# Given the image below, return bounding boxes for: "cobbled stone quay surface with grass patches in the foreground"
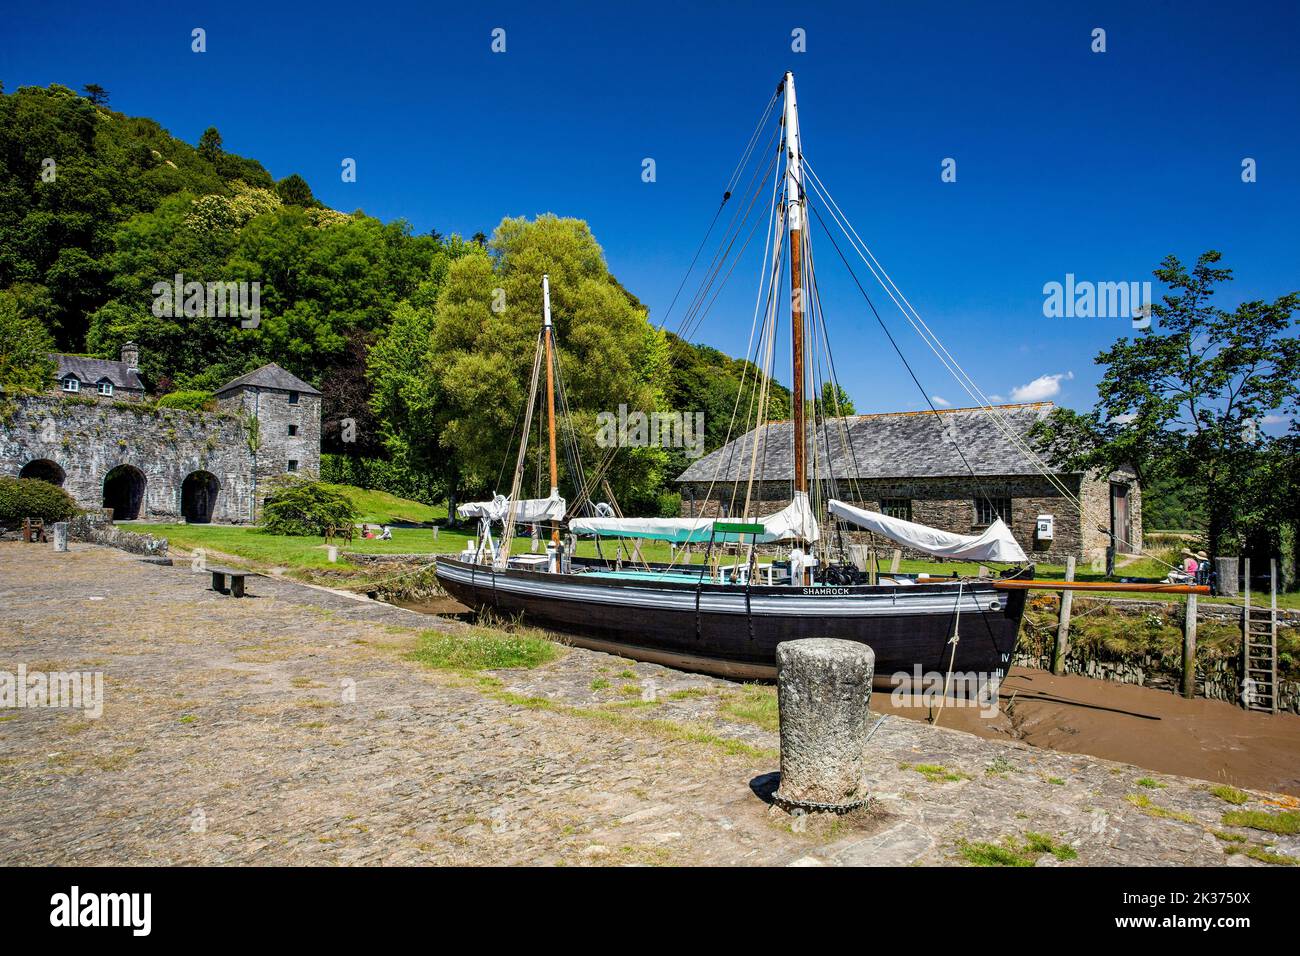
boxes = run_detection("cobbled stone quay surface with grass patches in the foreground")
[0,544,1300,865]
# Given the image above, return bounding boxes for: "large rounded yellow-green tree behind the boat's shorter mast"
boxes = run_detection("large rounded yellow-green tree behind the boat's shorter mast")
[371,215,667,507]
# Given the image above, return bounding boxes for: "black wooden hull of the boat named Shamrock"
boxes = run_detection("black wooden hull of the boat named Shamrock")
[437,558,1026,687]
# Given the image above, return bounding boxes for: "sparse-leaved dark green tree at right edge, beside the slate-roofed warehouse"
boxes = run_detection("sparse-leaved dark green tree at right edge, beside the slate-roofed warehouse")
[1039,251,1300,554]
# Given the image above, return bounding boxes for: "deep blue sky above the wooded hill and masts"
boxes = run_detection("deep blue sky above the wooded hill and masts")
[0,0,1300,421]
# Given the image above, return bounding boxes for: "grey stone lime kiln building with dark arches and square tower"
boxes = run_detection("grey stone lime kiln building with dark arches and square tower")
[0,343,321,523]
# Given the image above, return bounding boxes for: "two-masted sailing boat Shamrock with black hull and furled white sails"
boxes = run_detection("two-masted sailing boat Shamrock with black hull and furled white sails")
[437,73,1032,684]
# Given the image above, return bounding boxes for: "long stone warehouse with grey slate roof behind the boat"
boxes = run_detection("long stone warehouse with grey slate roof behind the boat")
[677,402,1141,563]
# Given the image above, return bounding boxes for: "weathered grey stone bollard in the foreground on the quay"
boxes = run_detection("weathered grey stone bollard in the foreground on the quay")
[772,637,876,813]
